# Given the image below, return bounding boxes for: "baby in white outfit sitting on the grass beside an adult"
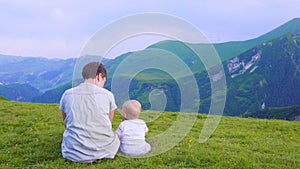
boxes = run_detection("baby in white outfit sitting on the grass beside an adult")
[116,100,151,156]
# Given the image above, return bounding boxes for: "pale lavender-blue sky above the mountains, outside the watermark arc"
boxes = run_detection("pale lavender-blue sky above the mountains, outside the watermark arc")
[0,0,300,59]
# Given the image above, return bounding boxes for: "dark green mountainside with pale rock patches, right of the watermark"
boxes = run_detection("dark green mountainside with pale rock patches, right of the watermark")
[224,34,300,115]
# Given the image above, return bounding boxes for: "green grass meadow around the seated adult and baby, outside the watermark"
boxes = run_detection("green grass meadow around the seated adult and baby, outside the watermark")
[0,99,300,169]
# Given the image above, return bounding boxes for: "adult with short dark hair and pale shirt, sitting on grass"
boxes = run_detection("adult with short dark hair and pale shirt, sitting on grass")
[60,62,120,162]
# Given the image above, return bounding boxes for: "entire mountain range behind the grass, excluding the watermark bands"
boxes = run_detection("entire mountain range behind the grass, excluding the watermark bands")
[0,18,300,118]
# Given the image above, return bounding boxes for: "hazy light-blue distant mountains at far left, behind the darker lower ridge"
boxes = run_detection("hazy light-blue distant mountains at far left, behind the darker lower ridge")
[0,55,76,91]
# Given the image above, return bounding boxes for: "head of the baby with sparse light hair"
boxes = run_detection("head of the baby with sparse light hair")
[122,100,142,120]
